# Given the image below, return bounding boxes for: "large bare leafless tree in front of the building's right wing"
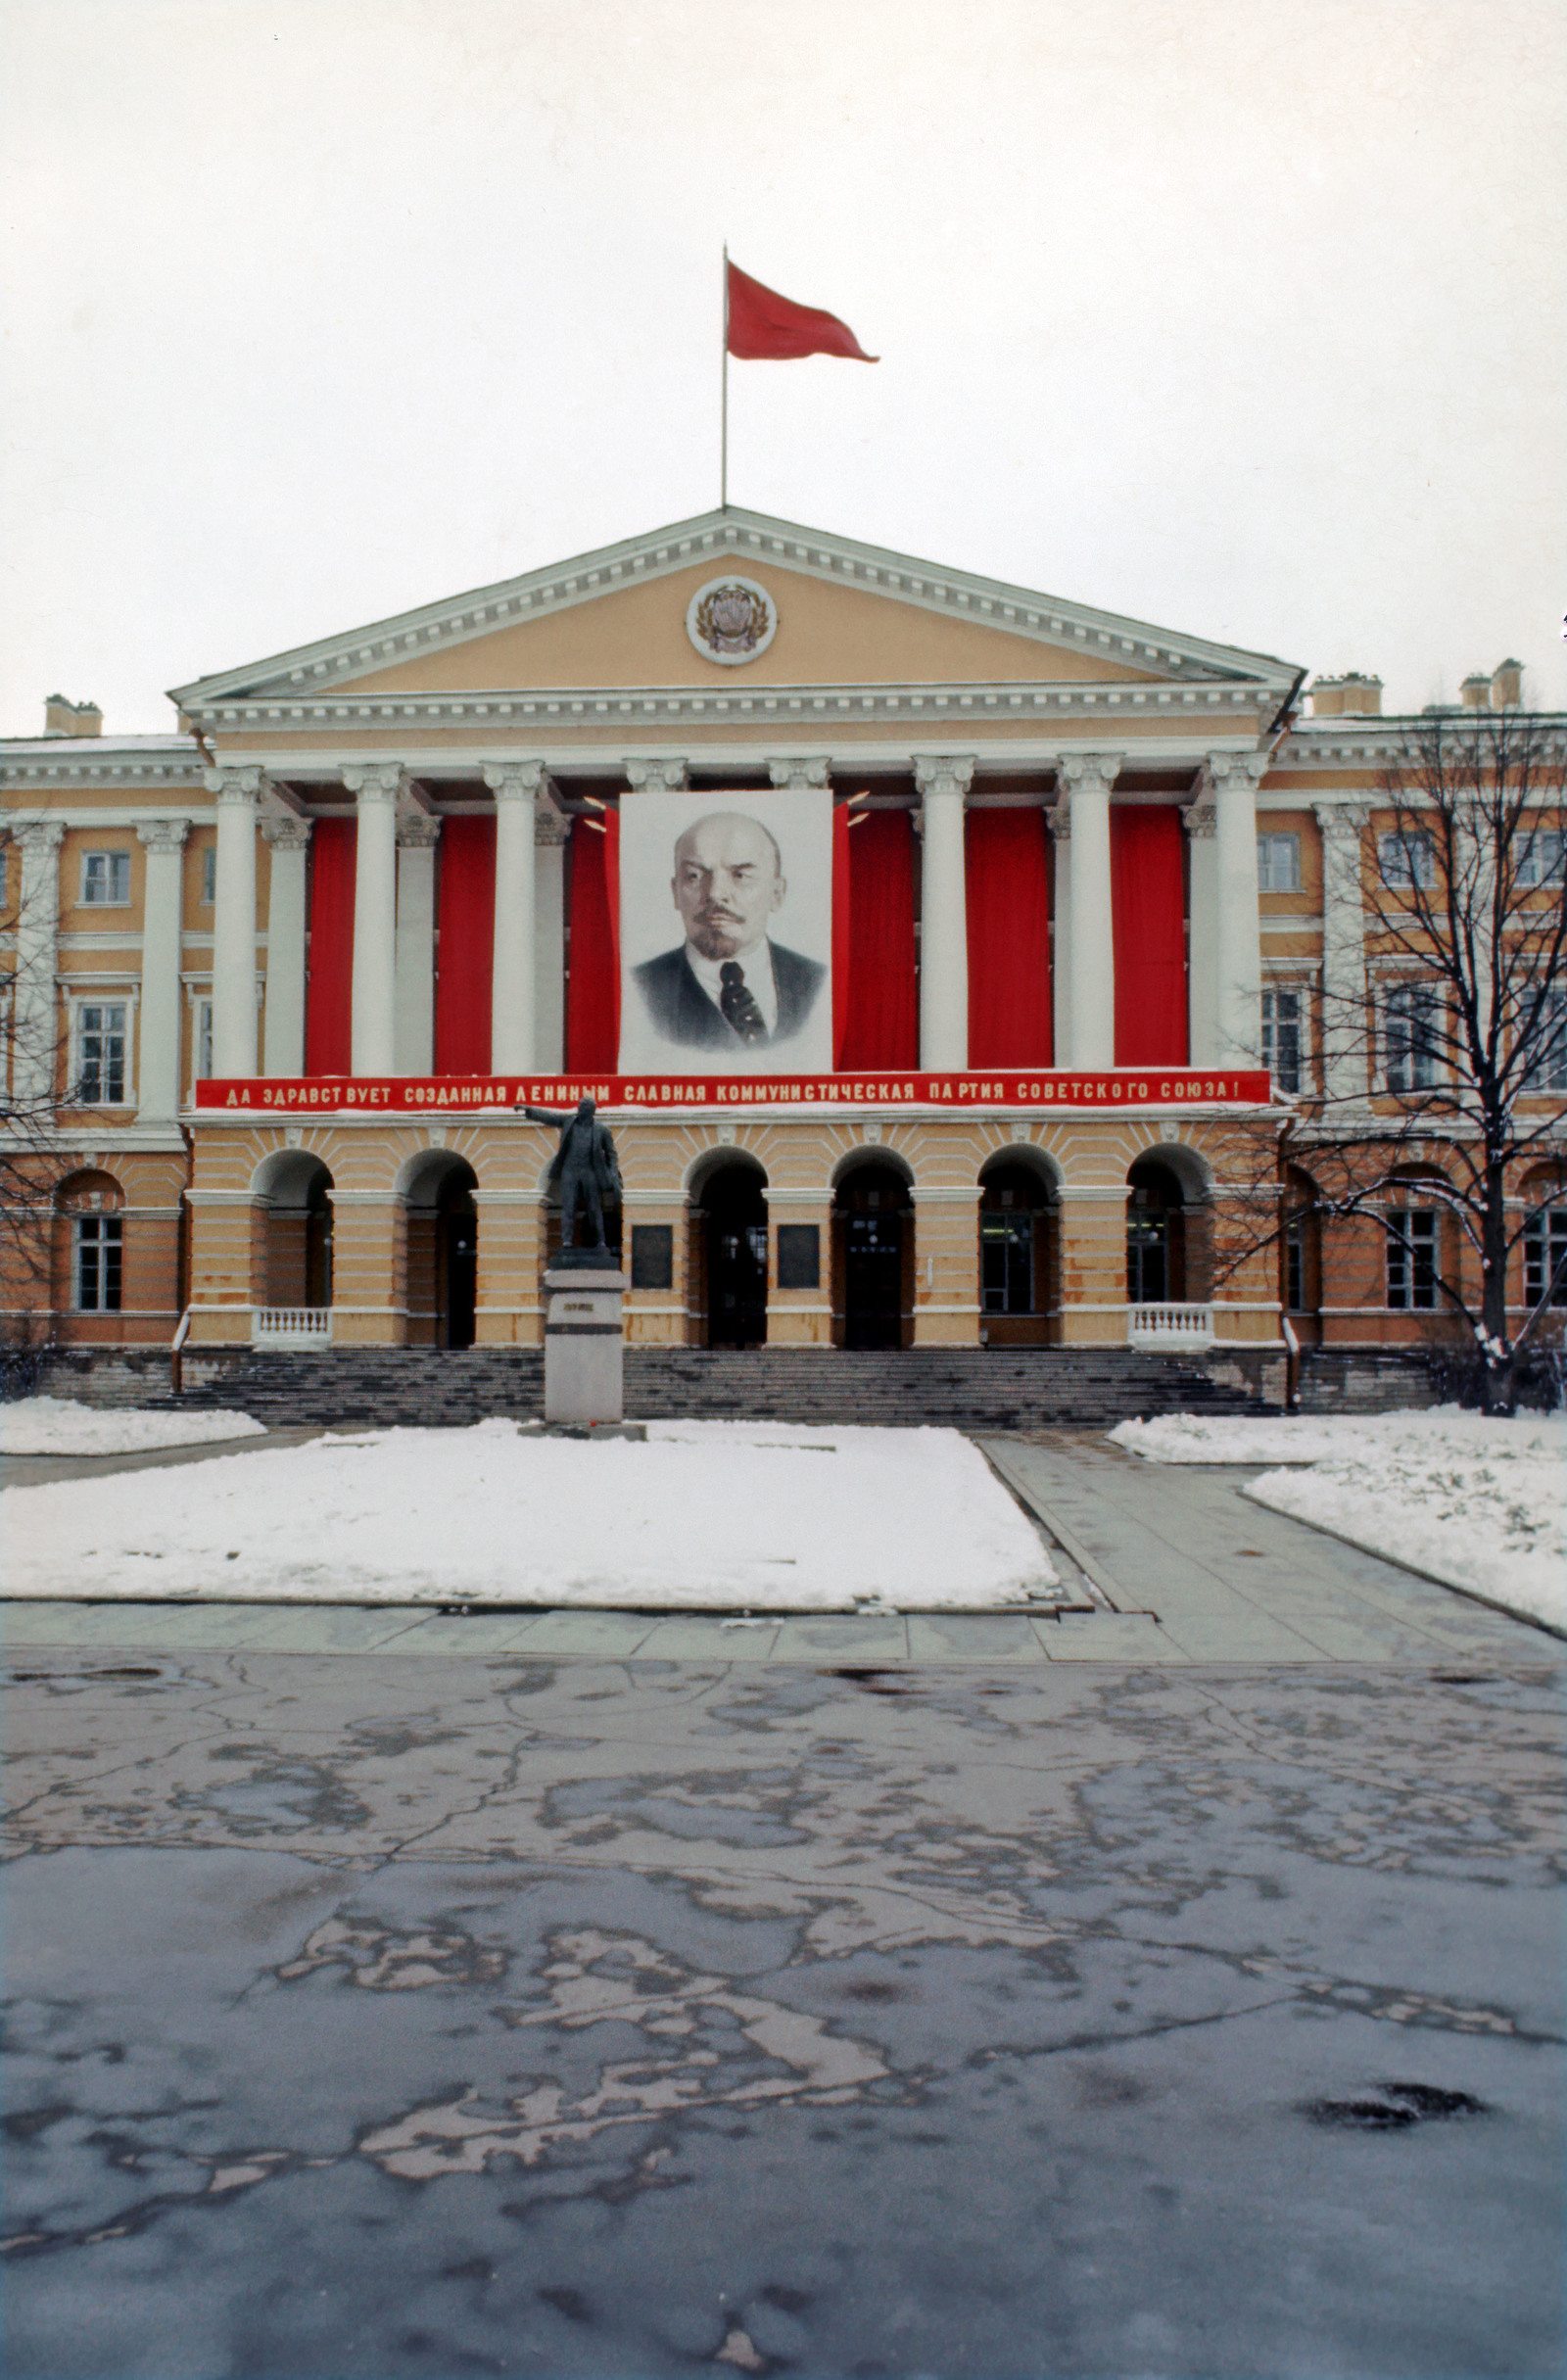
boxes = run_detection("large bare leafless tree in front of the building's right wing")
[1253,709,1567,1411]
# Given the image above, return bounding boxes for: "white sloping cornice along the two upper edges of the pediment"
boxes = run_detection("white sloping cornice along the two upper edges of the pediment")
[171,504,1298,716]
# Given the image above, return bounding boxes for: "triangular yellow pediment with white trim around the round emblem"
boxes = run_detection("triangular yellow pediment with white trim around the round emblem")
[174,507,1293,714]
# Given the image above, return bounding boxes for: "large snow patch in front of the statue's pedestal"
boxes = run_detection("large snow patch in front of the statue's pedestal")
[0,1418,1055,1611]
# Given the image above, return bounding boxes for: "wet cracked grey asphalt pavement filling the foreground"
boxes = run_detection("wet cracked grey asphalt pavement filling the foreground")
[5,1628,1565,2380]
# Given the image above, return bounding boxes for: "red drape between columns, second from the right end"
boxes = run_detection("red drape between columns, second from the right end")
[965,809,1055,1067]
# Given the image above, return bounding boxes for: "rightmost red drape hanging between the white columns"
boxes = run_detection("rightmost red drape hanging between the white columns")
[1110,802,1186,1067]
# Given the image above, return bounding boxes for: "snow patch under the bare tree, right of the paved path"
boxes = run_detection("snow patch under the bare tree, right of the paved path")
[1110,1404,1567,1633]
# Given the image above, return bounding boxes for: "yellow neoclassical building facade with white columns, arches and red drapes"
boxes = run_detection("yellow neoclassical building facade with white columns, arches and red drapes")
[0,507,1567,1352]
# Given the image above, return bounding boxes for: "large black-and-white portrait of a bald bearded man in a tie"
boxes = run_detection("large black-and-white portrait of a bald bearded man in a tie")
[619,787,833,1073]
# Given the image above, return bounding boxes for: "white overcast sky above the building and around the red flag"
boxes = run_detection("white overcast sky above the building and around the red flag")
[0,0,1567,736]
